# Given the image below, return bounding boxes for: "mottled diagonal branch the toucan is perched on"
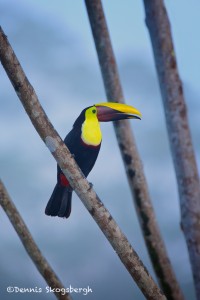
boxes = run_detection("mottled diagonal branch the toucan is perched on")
[0,28,166,299]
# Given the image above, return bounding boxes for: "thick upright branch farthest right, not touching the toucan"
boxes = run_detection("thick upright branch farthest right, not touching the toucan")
[144,0,200,299]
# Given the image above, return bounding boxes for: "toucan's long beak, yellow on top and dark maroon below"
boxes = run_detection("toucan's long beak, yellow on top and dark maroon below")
[95,102,142,122]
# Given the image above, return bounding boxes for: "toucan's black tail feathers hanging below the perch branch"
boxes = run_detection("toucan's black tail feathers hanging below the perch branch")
[45,183,72,218]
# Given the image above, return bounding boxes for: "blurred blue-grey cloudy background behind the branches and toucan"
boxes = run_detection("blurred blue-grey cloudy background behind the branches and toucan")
[0,0,200,300]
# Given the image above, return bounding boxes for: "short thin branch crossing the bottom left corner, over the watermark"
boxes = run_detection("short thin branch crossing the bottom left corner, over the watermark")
[0,180,72,300]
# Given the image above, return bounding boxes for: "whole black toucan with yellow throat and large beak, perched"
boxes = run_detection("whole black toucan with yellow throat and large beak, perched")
[45,102,141,218]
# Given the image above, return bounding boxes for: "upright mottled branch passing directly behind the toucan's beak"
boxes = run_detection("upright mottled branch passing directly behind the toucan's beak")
[85,0,183,300]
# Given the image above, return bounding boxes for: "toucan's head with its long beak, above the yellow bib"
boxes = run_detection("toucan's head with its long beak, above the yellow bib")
[74,102,141,126]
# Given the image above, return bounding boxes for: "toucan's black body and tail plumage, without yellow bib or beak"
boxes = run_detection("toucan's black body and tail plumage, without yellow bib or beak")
[45,108,101,218]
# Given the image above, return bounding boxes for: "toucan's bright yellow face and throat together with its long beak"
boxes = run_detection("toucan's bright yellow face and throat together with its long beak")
[81,102,141,146]
